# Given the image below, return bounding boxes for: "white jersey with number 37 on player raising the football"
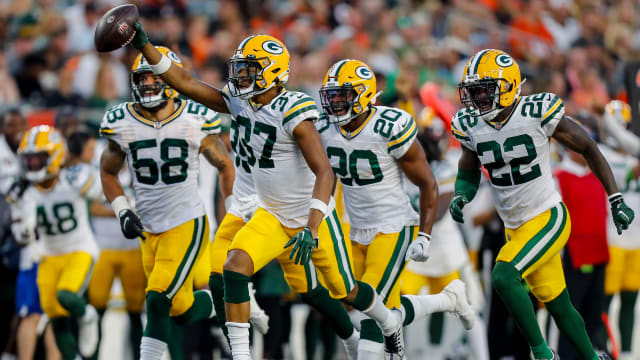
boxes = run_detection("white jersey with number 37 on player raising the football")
[223,87,318,228]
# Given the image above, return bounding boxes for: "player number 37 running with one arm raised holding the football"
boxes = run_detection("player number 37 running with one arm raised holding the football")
[125,23,424,359]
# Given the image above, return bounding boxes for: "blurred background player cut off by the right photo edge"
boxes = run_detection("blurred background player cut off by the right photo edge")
[602,100,640,360]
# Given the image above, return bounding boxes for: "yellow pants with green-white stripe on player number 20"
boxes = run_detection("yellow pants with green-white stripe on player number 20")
[352,226,418,309]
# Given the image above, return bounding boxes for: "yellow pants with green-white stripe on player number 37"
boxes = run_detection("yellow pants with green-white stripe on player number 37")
[230,208,355,299]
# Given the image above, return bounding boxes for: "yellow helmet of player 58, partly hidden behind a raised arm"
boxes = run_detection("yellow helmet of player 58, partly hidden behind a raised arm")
[129,46,183,108]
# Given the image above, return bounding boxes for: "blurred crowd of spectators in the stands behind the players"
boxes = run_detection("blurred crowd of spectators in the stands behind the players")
[0,0,640,359]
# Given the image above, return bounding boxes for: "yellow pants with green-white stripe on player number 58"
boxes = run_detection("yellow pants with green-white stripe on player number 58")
[140,215,209,316]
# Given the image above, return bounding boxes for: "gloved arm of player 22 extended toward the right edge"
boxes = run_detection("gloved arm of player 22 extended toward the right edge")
[553,116,634,234]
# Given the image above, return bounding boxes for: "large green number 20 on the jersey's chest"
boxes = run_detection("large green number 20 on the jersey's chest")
[327,146,384,186]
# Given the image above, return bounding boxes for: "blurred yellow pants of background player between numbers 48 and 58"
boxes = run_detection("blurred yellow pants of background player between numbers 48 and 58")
[88,249,147,312]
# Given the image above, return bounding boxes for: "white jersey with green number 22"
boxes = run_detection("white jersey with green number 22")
[451,93,564,229]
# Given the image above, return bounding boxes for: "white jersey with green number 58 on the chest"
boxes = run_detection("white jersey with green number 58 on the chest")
[100,100,220,233]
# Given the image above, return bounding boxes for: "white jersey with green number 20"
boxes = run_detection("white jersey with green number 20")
[317,106,419,244]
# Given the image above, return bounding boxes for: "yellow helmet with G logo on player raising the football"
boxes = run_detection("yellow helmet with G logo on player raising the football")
[228,35,289,99]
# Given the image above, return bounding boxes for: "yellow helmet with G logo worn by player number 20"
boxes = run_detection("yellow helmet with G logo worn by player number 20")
[320,59,377,126]
